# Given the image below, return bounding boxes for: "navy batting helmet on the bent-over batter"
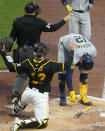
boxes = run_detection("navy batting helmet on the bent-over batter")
[81,53,94,70]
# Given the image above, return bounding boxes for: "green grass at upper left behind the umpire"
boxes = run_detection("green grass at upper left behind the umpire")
[0,0,35,69]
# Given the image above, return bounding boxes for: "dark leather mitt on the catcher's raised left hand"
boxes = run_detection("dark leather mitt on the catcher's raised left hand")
[0,36,13,53]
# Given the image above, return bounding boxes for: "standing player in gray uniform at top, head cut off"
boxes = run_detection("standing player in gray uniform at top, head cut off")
[61,0,94,40]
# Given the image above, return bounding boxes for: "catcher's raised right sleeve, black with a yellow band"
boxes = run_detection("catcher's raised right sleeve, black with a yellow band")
[51,51,74,73]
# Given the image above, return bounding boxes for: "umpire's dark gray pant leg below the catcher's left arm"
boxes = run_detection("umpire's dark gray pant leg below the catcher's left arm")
[12,72,27,94]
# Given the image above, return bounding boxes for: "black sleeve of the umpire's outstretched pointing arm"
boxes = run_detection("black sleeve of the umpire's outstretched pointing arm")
[42,19,66,32]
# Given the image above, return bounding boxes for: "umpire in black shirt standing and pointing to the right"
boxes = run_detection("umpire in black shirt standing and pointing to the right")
[0,2,72,104]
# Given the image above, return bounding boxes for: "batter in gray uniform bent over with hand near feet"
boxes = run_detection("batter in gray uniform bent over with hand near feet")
[58,34,97,106]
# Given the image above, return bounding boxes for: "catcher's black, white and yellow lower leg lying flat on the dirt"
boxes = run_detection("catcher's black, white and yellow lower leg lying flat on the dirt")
[14,118,48,131]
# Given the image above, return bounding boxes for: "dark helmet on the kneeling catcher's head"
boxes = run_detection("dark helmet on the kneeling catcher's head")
[34,42,48,57]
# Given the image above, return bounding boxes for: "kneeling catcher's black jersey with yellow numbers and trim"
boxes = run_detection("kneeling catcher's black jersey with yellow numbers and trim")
[16,53,73,92]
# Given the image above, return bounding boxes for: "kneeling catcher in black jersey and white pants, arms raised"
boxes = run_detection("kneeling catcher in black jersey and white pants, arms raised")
[3,43,75,131]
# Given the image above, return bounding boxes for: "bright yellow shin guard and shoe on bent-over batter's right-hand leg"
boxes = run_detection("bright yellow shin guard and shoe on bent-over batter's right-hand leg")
[79,82,92,105]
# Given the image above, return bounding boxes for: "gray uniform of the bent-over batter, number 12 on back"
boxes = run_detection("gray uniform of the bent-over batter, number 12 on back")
[58,34,97,65]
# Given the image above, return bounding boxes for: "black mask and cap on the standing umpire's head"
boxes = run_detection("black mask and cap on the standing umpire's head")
[25,2,41,16]
